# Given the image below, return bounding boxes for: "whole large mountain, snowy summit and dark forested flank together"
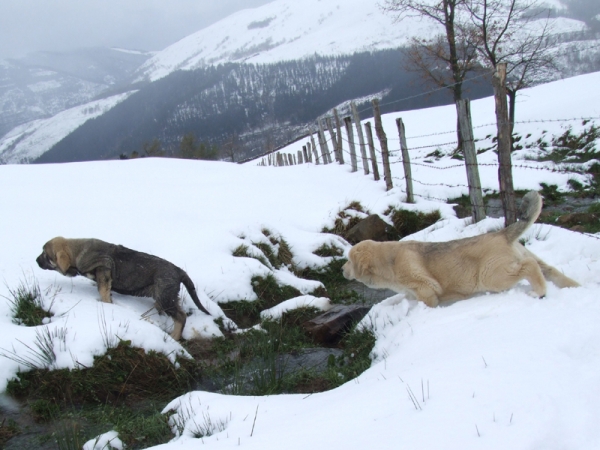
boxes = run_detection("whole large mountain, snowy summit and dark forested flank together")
[0,0,600,162]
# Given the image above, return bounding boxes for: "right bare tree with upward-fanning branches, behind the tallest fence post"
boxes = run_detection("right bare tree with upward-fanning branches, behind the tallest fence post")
[465,0,558,135]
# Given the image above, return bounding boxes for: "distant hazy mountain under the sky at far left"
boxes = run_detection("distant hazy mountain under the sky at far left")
[0,48,151,136]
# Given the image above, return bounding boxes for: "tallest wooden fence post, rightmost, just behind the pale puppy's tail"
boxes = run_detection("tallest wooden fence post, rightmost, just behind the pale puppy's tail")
[492,63,517,226]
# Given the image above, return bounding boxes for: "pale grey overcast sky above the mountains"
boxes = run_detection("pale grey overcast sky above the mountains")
[0,0,272,59]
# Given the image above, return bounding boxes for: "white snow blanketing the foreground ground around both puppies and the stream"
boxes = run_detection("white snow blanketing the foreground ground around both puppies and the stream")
[0,74,600,450]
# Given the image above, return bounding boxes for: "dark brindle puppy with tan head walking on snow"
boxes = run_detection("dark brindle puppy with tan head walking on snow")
[36,237,210,340]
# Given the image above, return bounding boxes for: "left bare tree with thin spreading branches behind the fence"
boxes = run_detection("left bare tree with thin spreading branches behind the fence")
[383,0,478,147]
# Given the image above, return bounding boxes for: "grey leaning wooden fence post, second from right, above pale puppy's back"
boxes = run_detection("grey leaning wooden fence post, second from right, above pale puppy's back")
[456,99,485,222]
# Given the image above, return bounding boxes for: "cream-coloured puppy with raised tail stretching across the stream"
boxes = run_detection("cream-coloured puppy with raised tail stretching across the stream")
[343,191,579,307]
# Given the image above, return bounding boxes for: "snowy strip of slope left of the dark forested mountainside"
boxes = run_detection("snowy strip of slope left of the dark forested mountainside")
[0,91,135,164]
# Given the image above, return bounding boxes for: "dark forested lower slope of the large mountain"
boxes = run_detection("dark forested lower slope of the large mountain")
[31,50,491,162]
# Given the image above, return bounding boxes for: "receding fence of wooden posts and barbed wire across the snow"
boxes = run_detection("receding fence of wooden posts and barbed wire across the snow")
[261,100,600,224]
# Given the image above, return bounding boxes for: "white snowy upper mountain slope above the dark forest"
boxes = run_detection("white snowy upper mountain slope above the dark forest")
[138,0,585,80]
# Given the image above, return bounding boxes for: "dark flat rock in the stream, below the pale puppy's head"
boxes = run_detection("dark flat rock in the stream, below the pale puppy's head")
[302,305,371,344]
